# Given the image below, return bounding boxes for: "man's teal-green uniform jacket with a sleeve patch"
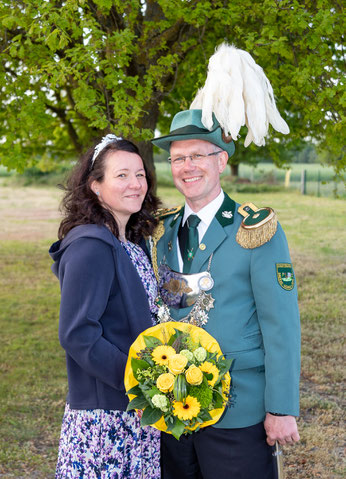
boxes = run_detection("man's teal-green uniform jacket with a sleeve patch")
[157,195,300,428]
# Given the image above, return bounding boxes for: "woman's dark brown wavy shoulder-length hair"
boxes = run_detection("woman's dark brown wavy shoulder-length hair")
[58,139,160,243]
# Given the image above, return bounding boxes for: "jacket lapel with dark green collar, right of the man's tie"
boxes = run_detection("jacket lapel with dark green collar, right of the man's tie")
[190,194,235,274]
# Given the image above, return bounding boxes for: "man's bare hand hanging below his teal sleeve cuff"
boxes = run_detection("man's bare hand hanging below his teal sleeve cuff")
[264,412,300,446]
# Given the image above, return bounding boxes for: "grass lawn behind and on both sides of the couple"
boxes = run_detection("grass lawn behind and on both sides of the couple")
[0,184,346,479]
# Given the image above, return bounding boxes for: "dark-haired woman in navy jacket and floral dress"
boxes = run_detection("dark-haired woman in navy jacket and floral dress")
[50,135,160,479]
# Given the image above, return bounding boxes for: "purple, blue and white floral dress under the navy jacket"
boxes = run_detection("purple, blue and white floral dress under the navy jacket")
[55,241,161,479]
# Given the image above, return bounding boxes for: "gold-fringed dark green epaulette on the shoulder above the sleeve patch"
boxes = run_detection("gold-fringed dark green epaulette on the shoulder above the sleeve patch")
[236,202,278,249]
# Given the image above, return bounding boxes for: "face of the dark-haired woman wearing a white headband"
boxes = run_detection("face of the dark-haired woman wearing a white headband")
[91,151,148,225]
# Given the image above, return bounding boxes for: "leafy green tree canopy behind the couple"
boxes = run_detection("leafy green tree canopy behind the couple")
[0,0,345,174]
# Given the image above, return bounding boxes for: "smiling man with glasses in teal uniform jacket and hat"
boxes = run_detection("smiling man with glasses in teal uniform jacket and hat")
[152,109,300,479]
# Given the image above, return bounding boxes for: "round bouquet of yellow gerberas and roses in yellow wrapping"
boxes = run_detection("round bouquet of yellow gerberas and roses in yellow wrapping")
[125,321,232,439]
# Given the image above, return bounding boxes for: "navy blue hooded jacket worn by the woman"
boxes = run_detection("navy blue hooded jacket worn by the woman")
[49,225,152,410]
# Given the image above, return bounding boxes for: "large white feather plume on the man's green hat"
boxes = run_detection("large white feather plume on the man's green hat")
[190,43,289,146]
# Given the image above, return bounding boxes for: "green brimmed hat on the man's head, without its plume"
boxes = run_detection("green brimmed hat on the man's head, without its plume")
[151,110,235,157]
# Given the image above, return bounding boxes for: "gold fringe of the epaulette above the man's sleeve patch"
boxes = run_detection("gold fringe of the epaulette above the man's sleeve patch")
[236,210,278,249]
